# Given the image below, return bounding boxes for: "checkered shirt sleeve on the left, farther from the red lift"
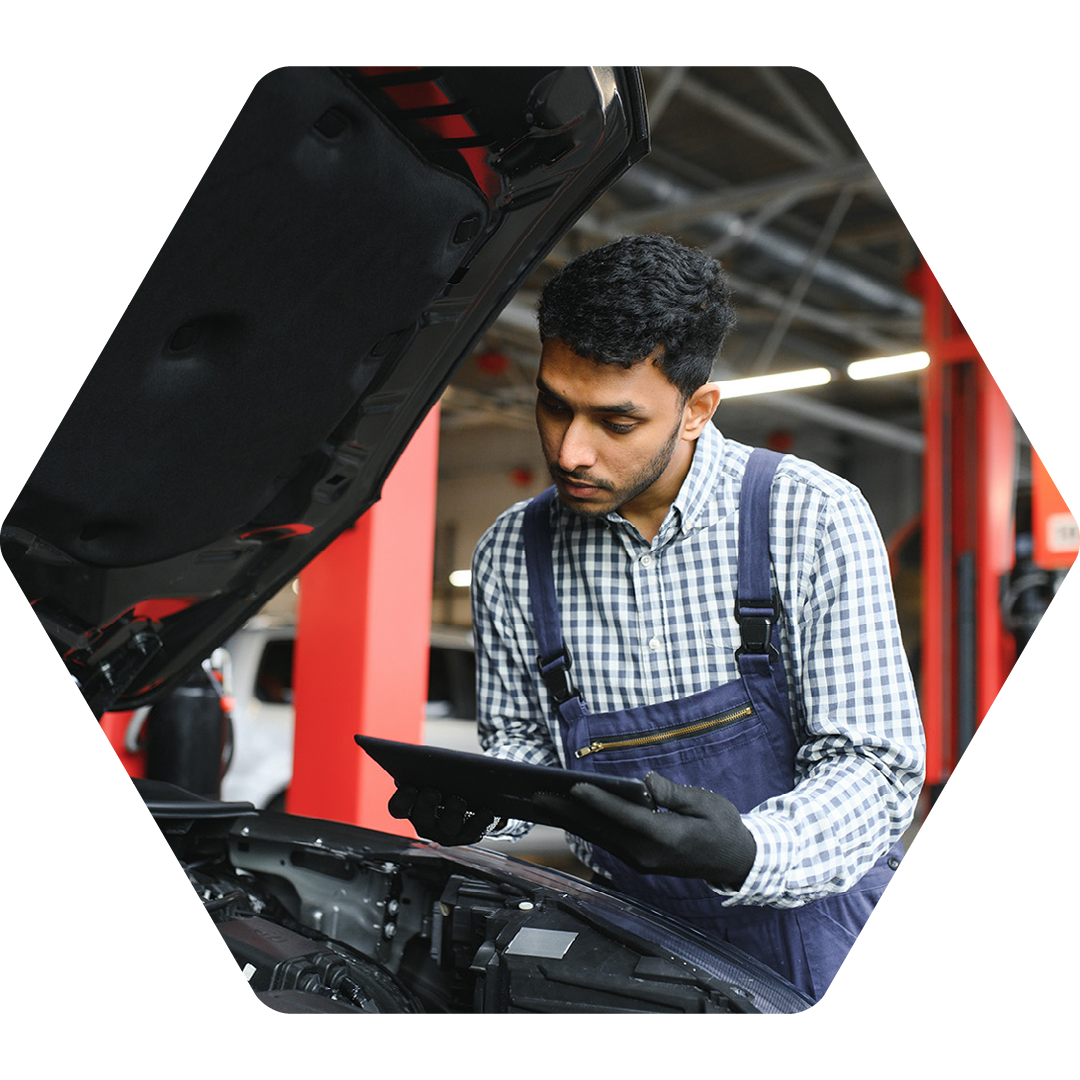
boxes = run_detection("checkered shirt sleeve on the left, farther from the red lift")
[470,523,561,839]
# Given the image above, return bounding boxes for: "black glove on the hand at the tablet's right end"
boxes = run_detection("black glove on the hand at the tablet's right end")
[535,772,757,889]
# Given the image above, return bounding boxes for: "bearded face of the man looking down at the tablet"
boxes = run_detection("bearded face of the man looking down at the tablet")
[537,338,693,521]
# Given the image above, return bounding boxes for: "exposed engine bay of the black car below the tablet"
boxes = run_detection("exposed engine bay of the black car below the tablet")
[149,805,814,1014]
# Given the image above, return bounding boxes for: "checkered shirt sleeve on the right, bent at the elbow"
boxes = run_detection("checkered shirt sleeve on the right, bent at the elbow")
[716,479,926,907]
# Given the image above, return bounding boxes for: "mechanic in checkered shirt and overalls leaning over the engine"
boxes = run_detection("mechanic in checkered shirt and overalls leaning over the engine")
[391,235,924,996]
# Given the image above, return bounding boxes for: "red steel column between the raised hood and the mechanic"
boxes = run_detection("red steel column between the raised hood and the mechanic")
[285,406,438,835]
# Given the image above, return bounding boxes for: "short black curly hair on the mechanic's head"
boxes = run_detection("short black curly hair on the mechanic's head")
[538,233,735,401]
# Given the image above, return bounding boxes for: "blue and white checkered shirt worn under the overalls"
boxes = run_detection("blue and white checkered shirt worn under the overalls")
[472,416,924,907]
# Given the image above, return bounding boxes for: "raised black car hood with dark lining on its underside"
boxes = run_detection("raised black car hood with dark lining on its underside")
[2,67,648,791]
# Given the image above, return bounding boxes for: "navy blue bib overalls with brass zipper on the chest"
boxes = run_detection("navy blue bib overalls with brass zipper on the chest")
[525,449,903,996]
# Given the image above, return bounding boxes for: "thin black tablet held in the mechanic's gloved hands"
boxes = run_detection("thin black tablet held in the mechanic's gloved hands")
[353,735,654,826]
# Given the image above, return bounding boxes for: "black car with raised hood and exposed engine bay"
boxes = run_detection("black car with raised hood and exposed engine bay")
[2,67,814,1013]
